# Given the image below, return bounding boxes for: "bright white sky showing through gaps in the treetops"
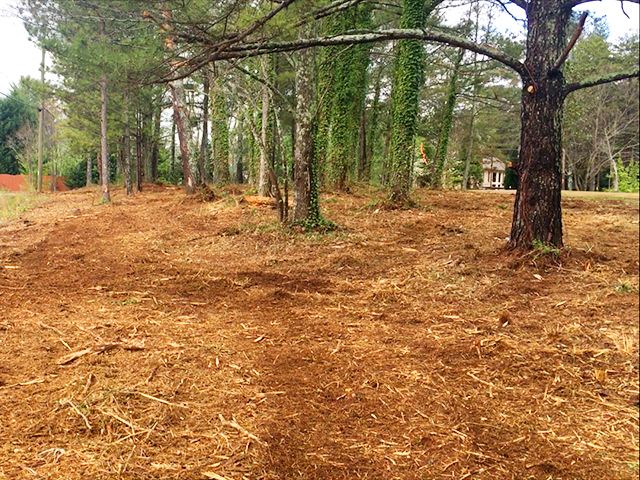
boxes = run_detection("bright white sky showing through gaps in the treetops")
[0,0,639,95]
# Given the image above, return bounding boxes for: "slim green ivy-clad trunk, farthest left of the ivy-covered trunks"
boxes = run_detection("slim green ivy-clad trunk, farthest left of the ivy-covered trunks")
[209,81,231,185]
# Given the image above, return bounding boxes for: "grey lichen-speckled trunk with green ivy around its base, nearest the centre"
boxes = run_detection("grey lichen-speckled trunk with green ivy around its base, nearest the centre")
[293,39,322,227]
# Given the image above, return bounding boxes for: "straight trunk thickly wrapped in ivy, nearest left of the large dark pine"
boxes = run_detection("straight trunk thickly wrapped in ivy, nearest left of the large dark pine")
[388,0,426,205]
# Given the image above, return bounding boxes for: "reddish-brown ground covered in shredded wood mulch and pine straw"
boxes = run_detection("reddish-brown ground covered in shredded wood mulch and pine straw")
[0,186,639,480]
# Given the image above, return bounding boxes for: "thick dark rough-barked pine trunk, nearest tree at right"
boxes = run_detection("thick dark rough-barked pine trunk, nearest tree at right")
[509,0,571,249]
